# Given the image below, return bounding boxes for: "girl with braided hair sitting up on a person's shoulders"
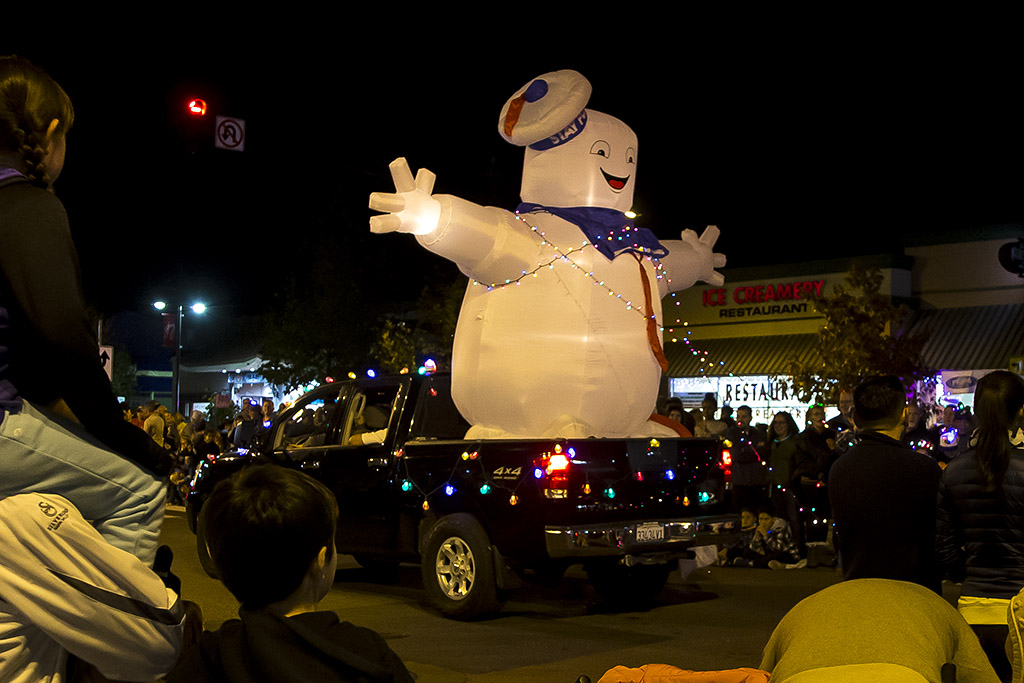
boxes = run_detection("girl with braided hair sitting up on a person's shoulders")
[0,56,170,564]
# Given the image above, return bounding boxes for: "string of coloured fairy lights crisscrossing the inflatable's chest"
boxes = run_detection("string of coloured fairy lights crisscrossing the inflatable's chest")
[464,212,732,377]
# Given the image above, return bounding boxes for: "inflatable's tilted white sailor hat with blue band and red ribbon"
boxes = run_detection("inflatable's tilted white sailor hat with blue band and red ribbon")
[498,69,591,152]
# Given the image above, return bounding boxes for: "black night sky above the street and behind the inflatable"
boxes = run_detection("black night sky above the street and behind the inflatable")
[9,22,1024,319]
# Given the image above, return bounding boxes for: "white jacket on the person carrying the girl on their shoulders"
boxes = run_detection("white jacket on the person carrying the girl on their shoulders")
[0,494,184,683]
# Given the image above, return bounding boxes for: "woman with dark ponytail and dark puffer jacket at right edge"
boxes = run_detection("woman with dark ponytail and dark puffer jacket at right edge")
[937,371,1024,681]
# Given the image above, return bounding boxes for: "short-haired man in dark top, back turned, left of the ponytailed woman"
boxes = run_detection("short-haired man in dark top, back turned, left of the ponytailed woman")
[828,376,942,592]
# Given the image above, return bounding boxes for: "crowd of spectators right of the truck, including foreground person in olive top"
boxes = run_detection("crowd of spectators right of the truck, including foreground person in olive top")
[655,371,1024,681]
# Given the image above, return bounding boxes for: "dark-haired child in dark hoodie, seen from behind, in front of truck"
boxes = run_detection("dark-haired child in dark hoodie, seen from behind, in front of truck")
[167,465,413,683]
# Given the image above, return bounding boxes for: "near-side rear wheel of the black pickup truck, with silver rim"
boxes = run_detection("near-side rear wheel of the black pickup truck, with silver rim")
[422,513,501,620]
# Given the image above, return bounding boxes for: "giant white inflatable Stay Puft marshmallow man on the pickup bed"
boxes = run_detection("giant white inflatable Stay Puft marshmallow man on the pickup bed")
[370,71,725,438]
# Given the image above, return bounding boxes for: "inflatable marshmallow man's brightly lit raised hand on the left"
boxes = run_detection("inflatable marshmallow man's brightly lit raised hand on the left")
[370,157,441,234]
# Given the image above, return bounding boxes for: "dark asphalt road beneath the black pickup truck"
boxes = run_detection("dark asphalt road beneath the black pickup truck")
[163,508,851,683]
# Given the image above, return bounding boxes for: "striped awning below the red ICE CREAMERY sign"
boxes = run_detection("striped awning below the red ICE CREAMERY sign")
[665,335,817,377]
